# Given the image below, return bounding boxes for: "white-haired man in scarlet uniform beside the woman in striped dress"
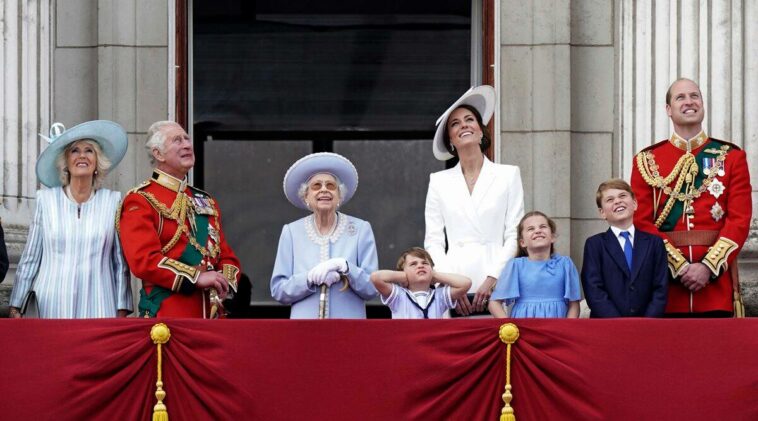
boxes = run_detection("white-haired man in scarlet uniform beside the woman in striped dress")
[118,121,240,318]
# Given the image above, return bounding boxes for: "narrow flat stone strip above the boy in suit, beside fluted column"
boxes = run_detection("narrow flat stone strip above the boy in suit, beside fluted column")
[570,0,618,268]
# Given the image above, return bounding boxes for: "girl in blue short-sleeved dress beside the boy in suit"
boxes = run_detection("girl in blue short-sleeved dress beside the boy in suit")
[489,211,581,318]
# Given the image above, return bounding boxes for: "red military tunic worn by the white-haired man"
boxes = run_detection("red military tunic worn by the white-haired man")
[119,170,241,318]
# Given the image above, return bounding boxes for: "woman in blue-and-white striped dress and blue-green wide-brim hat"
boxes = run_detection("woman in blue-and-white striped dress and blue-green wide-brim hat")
[10,120,132,318]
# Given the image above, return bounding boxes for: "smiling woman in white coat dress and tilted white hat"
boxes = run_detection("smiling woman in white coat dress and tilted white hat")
[424,85,524,316]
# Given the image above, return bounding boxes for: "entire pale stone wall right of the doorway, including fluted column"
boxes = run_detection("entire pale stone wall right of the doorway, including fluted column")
[499,0,758,315]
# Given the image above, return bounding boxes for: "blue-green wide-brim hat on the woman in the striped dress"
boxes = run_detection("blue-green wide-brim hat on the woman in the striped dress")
[36,120,128,187]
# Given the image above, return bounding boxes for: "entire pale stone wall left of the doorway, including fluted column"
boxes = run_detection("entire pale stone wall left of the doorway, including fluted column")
[0,0,169,304]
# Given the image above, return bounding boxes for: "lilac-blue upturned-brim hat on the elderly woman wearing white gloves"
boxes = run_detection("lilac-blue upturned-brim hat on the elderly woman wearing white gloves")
[283,152,358,209]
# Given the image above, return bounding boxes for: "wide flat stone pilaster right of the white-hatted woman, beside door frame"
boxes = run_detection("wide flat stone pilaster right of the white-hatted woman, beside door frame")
[499,0,572,254]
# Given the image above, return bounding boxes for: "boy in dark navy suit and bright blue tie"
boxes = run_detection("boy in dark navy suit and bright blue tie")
[582,179,668,317]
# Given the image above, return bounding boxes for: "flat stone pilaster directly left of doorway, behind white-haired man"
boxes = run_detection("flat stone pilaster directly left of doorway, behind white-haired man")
[92,0,168,193]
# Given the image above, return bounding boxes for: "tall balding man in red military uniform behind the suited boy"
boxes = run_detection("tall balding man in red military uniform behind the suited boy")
[631,79,752,317]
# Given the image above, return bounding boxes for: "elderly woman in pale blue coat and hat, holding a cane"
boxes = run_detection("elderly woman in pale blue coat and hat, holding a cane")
[271,152,378,319]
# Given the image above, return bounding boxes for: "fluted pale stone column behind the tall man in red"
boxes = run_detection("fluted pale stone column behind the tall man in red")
[613,0,758,315]
